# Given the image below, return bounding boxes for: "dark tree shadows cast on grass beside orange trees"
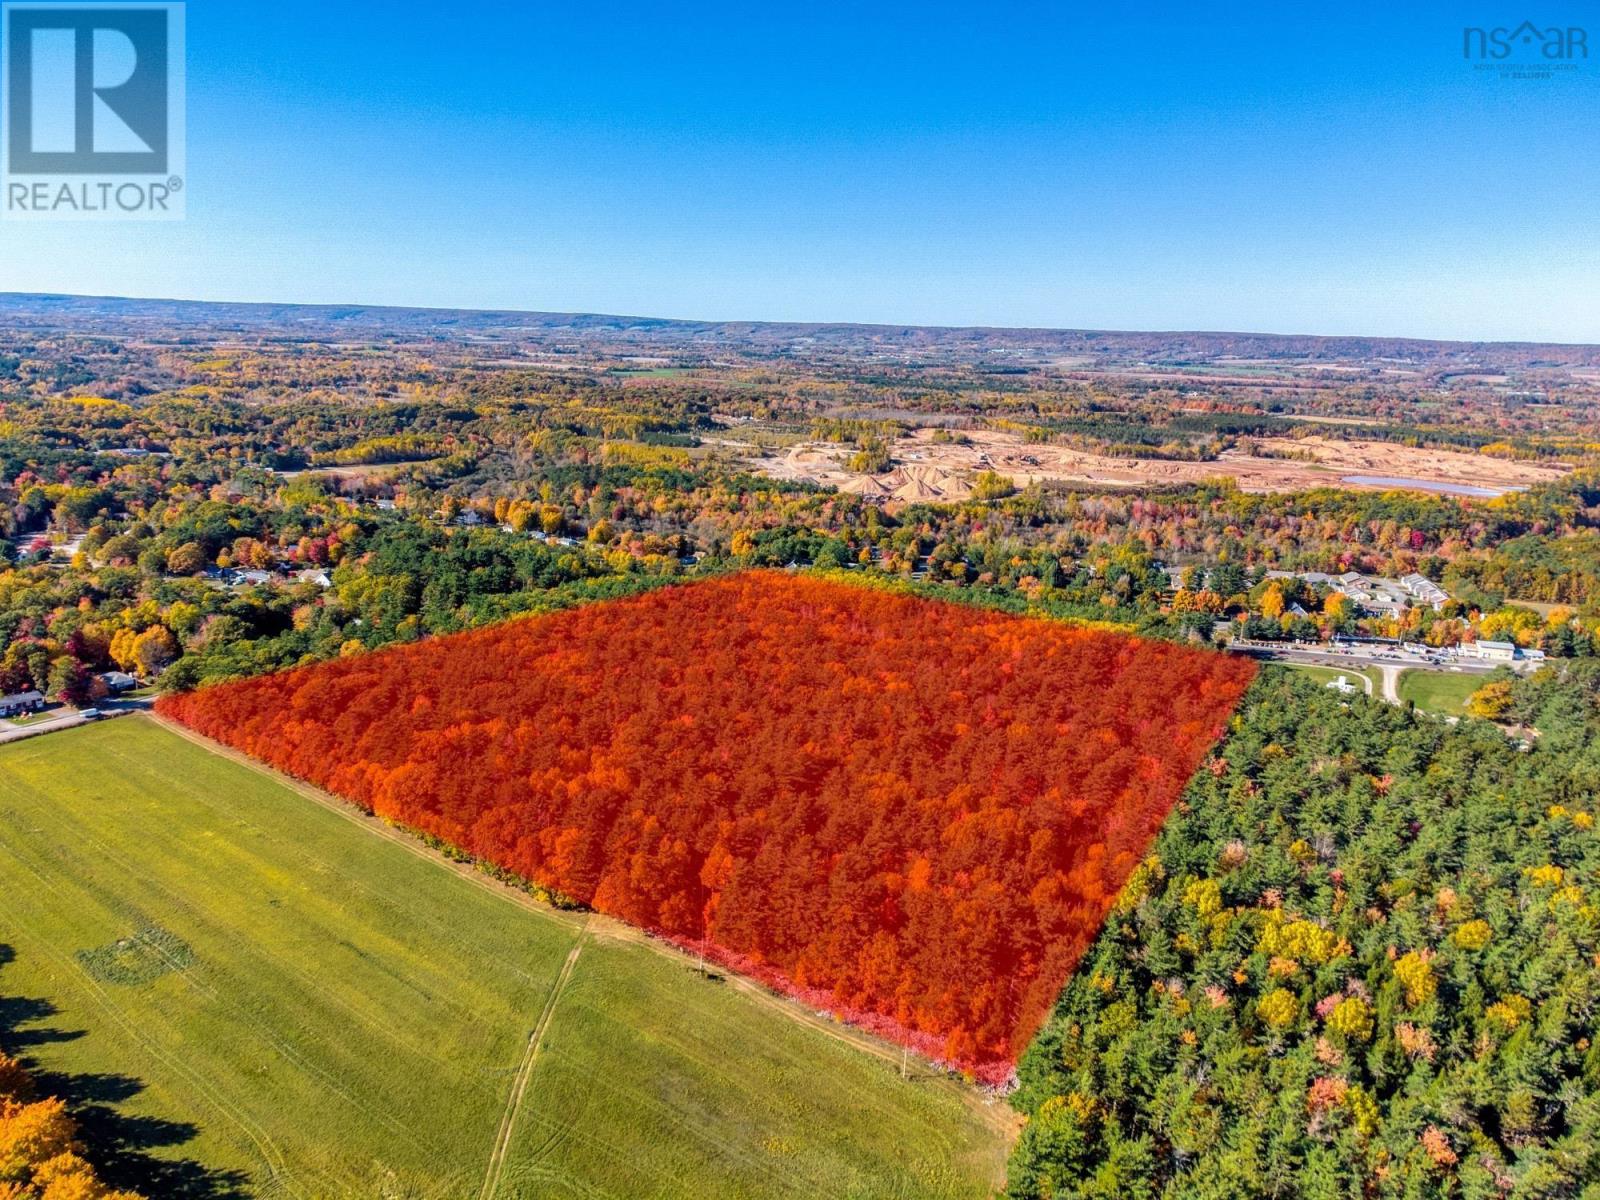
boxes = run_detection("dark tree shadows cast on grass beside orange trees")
[0,942,250,1200]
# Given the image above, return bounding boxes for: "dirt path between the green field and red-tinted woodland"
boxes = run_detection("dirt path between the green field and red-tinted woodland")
[144,712,1022,1146]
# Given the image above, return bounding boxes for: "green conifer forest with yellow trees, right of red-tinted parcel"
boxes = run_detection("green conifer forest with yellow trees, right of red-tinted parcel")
[1006,662,1600,1200]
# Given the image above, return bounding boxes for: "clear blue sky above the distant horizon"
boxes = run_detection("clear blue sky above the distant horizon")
[0,0,1600,341]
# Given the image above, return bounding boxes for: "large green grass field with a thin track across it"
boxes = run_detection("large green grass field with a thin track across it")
[0,717,1008,1200]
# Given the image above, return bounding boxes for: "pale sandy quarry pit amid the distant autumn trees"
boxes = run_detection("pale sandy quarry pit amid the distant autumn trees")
[750,429,1570,502]
